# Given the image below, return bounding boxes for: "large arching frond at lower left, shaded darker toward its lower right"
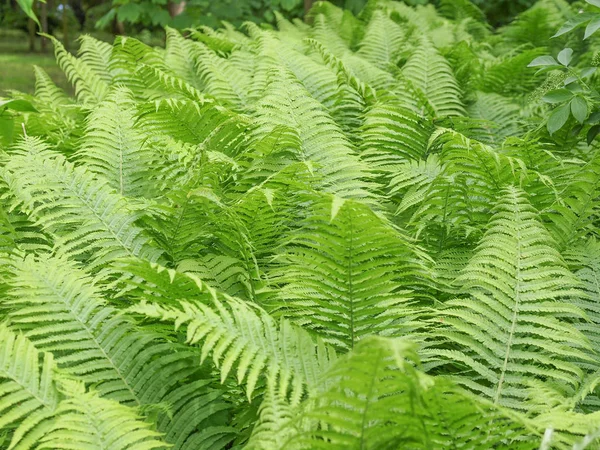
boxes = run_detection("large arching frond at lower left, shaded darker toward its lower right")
[6,256,233,450]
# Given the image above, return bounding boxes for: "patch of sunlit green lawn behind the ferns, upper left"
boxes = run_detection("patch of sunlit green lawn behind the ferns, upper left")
[0,31,71,97]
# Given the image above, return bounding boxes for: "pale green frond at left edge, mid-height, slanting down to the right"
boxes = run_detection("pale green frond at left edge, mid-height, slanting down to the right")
[3,137,161,270]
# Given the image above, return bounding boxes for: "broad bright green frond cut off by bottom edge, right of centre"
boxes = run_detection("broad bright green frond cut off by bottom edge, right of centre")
[271,337,537,450]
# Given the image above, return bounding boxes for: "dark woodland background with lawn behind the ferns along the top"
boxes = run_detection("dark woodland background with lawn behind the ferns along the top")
[0,0,568,95]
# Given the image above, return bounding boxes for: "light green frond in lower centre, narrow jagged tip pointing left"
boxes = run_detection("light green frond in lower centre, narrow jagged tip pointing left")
[131,290,335,402]
